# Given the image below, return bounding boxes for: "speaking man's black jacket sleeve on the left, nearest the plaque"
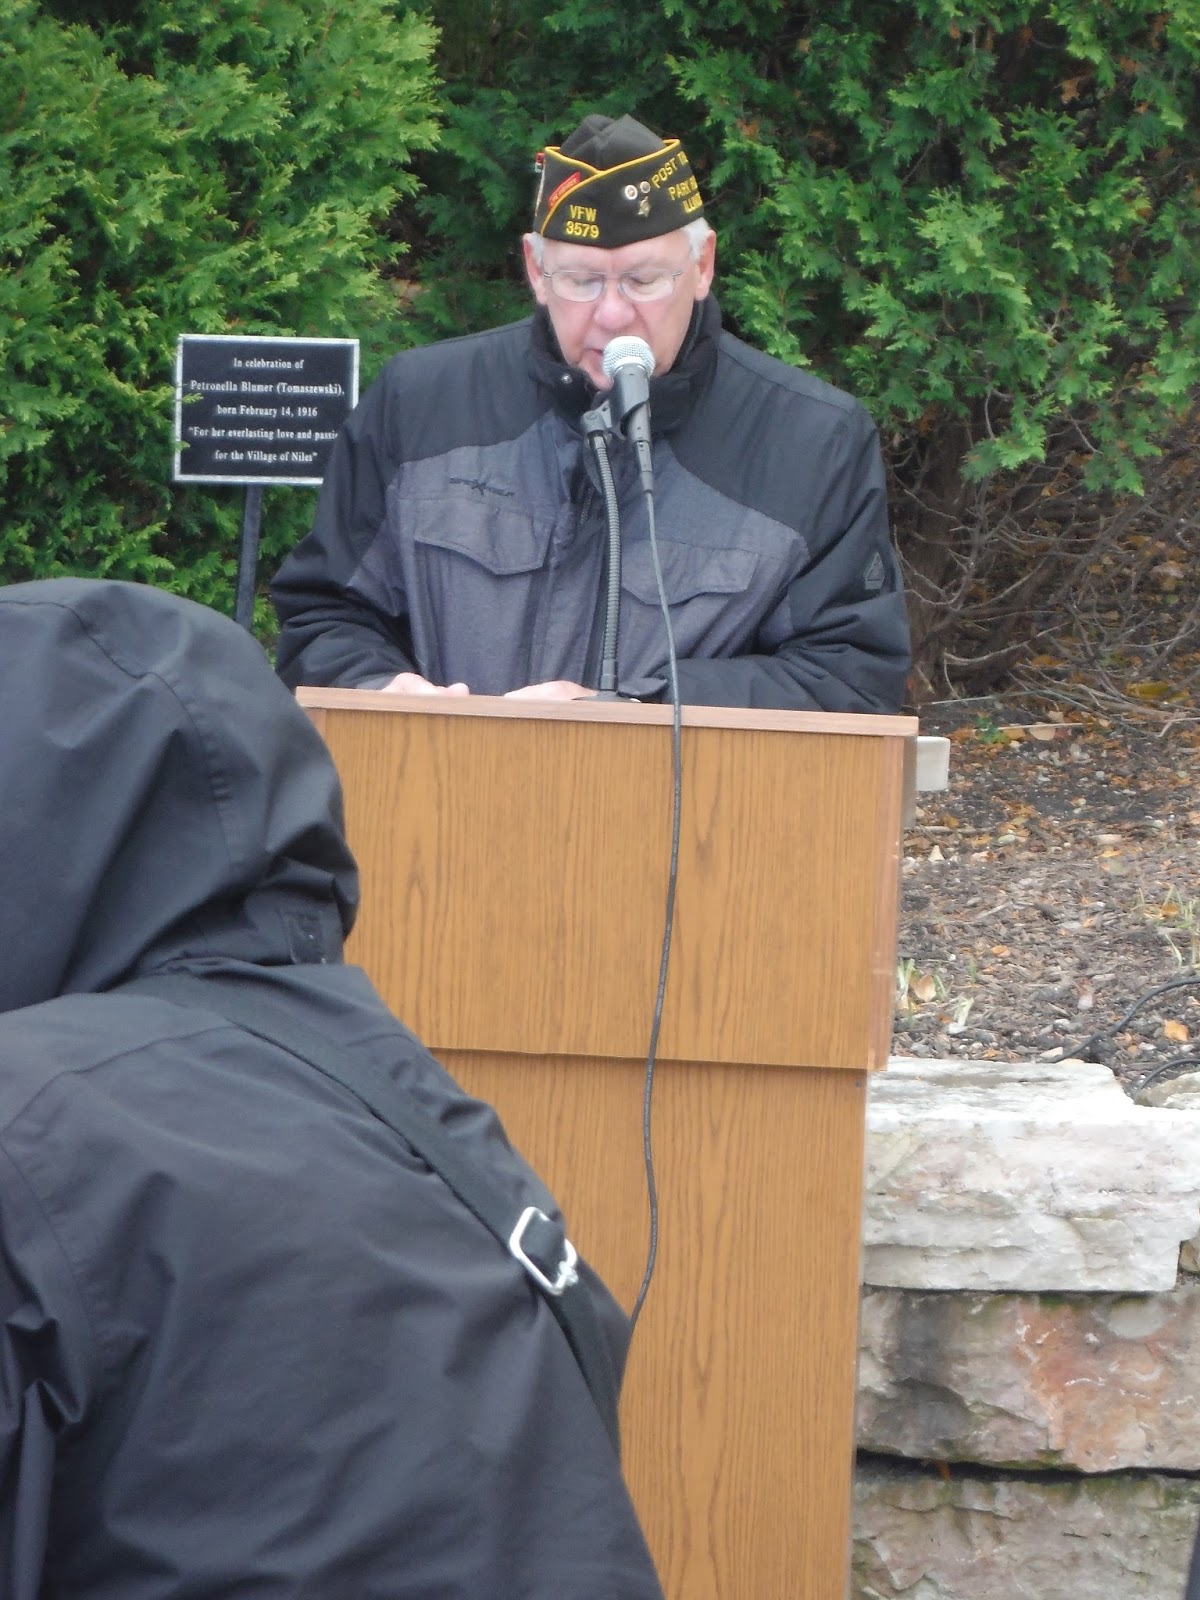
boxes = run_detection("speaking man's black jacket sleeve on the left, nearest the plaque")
[270,370,414,688]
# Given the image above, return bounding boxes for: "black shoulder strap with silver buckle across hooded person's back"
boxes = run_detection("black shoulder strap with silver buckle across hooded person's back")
[118,973,621,1454]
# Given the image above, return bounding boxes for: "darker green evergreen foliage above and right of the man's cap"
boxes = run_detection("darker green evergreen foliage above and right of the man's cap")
[421,0,1200,476]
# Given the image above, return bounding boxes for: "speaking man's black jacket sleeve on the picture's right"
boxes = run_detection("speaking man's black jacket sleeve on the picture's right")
[678,408,910,712]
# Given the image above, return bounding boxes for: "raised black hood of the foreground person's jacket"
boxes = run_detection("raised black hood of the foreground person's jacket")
[0,578,358,1013]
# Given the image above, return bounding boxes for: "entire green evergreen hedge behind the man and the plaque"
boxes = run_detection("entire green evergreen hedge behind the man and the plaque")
[0,0,1200,681]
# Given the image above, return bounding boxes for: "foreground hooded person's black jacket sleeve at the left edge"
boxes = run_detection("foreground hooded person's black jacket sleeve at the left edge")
[0,1150,91,1600]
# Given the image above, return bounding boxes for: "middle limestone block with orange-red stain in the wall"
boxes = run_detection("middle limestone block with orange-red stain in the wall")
[858,1282,1200,1472]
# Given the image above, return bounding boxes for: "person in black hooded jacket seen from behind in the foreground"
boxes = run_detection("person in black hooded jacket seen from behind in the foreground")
[0,579,661,1600]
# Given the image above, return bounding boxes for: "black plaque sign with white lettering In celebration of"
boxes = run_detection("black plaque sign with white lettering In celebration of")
[174,333,358,485]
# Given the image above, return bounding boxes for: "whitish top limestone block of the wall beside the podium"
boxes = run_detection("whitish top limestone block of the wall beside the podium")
[864,1059,1200,1293]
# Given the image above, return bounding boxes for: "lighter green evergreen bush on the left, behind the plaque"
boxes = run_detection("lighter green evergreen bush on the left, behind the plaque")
[0,0,435,610]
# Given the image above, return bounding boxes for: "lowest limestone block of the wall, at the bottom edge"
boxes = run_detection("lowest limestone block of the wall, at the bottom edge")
[850,1462,1200,1600]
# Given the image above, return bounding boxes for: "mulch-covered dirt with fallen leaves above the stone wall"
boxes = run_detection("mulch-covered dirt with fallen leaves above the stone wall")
[893,698,1200,1093]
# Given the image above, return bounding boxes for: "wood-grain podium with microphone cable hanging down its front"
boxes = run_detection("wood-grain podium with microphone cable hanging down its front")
[299,690,917,1600]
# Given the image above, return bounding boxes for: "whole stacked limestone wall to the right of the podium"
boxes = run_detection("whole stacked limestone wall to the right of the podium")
[851,1061,1200,1600]
